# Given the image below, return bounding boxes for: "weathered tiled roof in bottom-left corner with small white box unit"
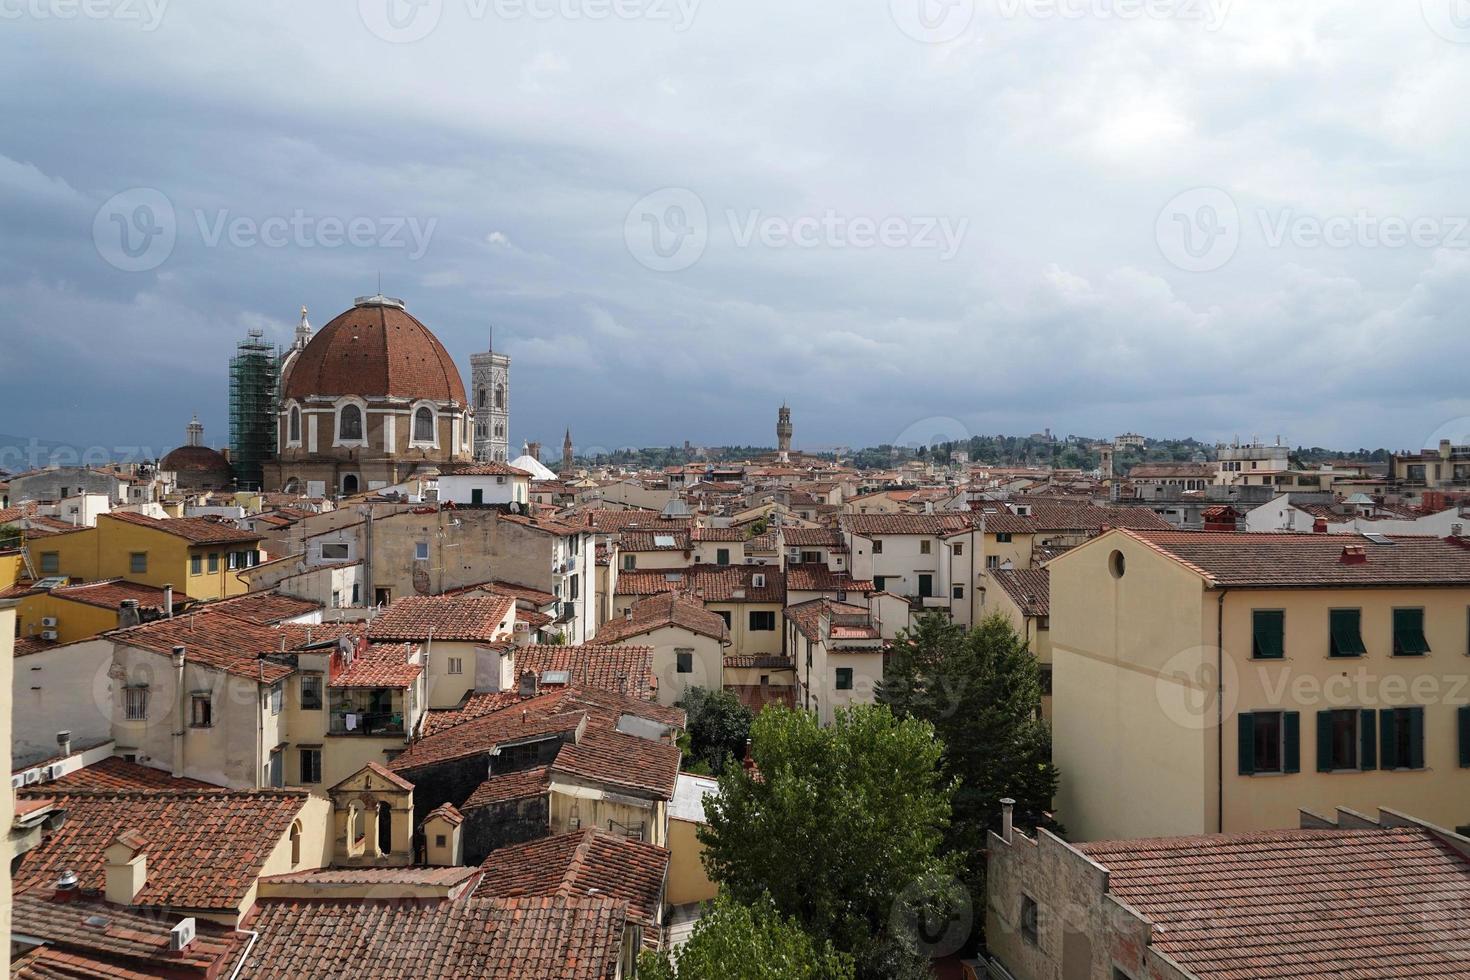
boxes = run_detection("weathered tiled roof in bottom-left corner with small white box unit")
[9,887,248,979]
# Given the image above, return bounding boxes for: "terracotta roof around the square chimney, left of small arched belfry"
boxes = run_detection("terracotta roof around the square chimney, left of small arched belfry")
[15,788,309,912]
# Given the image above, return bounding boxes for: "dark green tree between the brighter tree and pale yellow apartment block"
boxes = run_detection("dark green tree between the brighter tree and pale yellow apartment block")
[878,614,1060,937]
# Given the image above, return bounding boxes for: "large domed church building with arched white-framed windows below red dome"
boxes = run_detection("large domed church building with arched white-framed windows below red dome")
[263,295,475,497]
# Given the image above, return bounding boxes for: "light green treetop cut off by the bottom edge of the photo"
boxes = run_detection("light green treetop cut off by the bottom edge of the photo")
[638,895,854,980]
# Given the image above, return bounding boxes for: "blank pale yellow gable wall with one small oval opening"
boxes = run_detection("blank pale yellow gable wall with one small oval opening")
[1050,533,1217,840]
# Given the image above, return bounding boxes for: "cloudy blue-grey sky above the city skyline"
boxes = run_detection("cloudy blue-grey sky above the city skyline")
[0,0,1470,469]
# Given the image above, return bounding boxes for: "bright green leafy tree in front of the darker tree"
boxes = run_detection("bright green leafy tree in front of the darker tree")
[700,705,956,979]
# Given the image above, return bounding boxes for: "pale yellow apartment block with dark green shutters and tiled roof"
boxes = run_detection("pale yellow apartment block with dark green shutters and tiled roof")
[1048,530,1470,840]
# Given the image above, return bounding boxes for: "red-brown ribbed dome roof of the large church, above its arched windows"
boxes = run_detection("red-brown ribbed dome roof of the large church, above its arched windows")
[284,295,466,406]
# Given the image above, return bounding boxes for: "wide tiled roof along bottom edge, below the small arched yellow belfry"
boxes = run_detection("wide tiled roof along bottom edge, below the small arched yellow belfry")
[240,896,628,980]
